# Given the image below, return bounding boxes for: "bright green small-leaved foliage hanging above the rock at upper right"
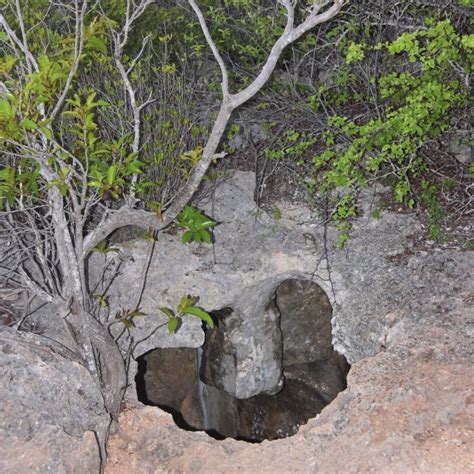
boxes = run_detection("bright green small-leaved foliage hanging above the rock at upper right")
[302,20,473,244]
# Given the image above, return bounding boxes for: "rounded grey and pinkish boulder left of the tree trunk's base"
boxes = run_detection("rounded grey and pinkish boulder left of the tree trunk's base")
[0,328,109,473]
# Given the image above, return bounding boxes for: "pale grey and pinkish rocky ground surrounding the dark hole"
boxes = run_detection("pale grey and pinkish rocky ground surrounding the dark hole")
[0,172,474,474]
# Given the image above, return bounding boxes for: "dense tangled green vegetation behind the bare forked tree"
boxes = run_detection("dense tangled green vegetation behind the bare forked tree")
[0,0,473,243]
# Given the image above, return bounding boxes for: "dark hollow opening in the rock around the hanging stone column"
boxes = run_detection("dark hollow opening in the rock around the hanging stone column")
[136,279,350,442]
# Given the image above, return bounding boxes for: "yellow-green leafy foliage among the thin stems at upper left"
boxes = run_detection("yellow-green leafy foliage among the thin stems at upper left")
[0,8,143,206]
